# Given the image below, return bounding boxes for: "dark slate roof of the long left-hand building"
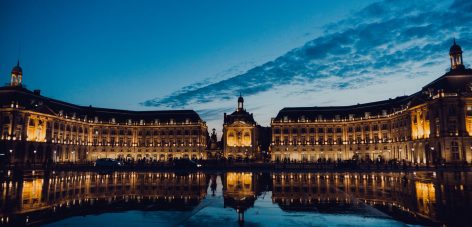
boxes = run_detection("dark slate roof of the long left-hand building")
[0,86,202,123]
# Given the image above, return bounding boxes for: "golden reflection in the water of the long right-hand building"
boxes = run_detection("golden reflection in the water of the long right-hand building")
[272,173,472,222]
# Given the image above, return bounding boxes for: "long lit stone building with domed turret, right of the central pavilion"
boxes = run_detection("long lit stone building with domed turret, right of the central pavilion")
[270,41,472,165]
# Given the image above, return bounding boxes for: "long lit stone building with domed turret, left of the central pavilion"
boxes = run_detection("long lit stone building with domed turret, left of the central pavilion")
[0,65,208,164]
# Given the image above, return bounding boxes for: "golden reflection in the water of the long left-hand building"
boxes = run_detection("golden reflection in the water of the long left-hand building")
[0,172,207,223]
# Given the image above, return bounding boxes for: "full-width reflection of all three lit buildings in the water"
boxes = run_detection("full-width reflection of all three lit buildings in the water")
[0,171,472,226]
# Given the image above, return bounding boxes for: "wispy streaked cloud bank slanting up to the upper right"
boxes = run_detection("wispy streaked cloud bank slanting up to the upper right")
[143,0,472,129]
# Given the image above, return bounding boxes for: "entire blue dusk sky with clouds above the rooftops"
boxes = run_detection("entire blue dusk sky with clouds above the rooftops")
[0,0,472,130]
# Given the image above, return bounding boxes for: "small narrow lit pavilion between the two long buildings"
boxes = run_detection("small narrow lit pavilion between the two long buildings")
[223,96,260,159]
